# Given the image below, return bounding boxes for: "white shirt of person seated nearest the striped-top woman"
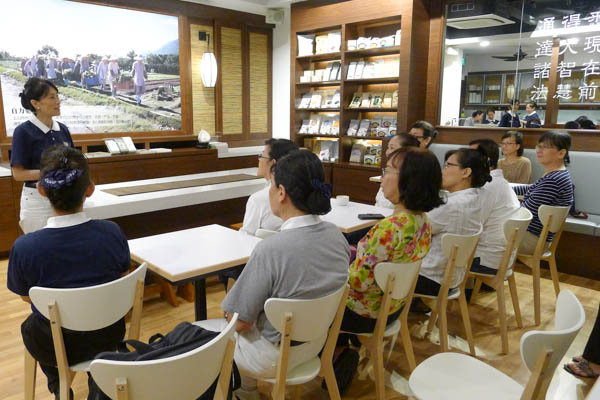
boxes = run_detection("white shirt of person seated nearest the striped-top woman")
[475,169,521,269]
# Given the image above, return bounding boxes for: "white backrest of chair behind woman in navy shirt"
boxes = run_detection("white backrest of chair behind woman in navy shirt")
[29,263,146,331]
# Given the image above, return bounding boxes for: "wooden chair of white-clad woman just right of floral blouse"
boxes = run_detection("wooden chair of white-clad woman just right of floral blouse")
[414,229,481,356]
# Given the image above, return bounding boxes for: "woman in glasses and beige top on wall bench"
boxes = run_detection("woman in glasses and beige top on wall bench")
[498,131,531,184]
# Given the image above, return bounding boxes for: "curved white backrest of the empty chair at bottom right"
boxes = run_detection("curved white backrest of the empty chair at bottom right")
[521,289,585,376]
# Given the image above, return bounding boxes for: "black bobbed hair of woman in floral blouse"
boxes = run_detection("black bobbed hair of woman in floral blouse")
[388,147,444,212]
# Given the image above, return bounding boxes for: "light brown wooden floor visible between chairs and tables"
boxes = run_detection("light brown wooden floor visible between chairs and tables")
[0,260,600,400]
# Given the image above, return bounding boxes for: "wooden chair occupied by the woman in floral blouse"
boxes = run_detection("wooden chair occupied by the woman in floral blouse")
[346,260,422,400]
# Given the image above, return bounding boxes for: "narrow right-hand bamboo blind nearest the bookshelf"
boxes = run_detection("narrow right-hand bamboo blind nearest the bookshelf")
[249,32,269,134]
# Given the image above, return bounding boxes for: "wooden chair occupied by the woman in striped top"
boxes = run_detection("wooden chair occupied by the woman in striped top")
[517,205,569,325]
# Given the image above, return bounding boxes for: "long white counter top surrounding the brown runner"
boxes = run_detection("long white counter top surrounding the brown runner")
[83,168,266,219]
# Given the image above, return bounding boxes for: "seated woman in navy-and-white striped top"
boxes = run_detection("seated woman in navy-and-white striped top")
[513,131,573,254]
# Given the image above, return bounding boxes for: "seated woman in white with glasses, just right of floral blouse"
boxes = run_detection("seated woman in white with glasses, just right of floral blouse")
[415,148,492,296]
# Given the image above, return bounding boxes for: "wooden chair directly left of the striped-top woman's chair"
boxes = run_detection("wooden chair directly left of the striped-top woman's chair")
[467,208,533,354]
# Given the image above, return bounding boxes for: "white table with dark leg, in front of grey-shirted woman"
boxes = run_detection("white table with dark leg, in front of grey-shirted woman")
[129,224,260,321]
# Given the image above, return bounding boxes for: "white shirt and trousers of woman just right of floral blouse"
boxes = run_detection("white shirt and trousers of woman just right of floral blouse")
[420,188,481,288]
